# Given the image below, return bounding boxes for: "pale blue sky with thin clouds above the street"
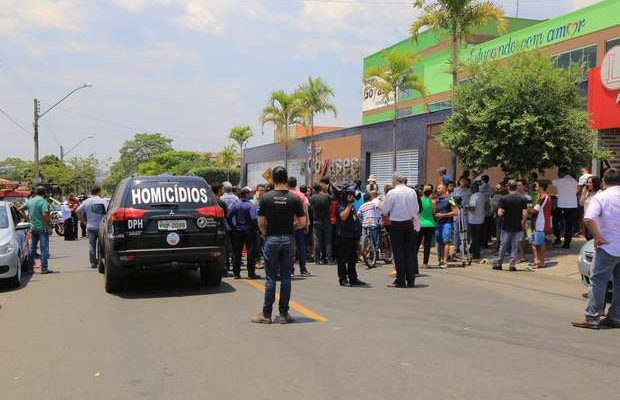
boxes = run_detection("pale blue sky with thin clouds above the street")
[0,0,596,161]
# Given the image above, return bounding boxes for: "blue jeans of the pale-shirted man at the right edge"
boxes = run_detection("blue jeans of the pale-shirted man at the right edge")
[586,248,620,322]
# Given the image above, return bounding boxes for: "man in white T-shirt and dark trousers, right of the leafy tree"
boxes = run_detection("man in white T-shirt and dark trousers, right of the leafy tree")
[552,167,578,249]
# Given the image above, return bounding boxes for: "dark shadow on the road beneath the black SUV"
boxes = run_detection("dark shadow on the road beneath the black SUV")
[116,271,235,299]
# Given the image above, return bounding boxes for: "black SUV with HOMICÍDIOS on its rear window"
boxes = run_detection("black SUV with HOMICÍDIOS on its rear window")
[93,175,225,293]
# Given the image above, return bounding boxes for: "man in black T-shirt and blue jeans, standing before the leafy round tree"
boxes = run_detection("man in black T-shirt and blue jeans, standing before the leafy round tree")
[493,181,527,271]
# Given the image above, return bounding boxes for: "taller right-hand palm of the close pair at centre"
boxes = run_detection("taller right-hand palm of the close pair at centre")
[297,76,337,184]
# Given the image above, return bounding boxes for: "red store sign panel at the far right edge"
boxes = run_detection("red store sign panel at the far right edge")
[588,67,620,130]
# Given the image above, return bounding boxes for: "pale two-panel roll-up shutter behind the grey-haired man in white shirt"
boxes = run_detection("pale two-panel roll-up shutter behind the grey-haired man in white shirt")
[370,149,420,192]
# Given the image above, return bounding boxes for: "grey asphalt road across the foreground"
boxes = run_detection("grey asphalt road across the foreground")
[0,239,620,400]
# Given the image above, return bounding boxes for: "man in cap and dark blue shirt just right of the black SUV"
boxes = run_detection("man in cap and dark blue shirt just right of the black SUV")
[228,187,260,279]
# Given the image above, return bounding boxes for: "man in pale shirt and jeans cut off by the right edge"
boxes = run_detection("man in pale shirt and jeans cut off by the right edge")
[573,168,620,329]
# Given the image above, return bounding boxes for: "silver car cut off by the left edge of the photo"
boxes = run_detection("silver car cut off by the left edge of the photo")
[0,201,30,287]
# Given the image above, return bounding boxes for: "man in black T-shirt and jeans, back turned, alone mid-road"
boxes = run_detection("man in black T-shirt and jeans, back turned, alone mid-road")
[252,167,306,324]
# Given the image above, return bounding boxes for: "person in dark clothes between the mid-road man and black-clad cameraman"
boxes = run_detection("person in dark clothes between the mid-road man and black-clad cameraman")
[310,183,333,264]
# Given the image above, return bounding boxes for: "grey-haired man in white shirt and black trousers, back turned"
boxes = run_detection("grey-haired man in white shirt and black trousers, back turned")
[383,172,420,288]
